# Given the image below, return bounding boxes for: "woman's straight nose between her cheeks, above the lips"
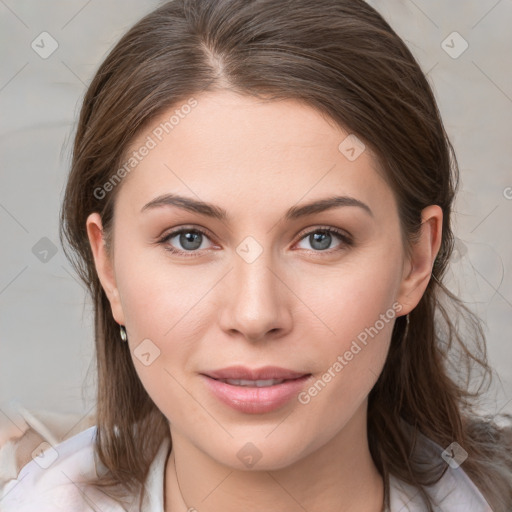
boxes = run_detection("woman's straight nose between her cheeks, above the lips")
[219,245,293,341]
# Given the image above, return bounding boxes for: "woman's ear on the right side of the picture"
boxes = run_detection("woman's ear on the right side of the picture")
[397,205,443,315]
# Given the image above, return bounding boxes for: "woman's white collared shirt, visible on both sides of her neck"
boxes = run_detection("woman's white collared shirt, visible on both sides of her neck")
[0,427,492,512]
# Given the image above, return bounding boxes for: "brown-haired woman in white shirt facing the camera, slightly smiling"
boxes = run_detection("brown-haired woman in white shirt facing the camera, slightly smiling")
[0,0,512,512]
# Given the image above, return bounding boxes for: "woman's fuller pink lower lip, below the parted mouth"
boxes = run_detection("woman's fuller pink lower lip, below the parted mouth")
[201,375,311,414]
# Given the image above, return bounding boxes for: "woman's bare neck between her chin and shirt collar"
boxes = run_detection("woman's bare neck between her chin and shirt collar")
[165,404,384,512]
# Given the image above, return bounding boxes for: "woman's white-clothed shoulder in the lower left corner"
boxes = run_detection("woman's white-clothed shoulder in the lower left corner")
[0,426,127,512]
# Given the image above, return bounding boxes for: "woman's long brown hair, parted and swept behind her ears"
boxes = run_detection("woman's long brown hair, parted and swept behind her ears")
[61,0,512,511]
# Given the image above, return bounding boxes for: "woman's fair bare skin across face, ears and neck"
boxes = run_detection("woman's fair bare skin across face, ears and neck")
[87,91,442,512]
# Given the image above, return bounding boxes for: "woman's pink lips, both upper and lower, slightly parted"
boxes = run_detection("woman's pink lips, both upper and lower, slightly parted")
[201,366,311,414]
